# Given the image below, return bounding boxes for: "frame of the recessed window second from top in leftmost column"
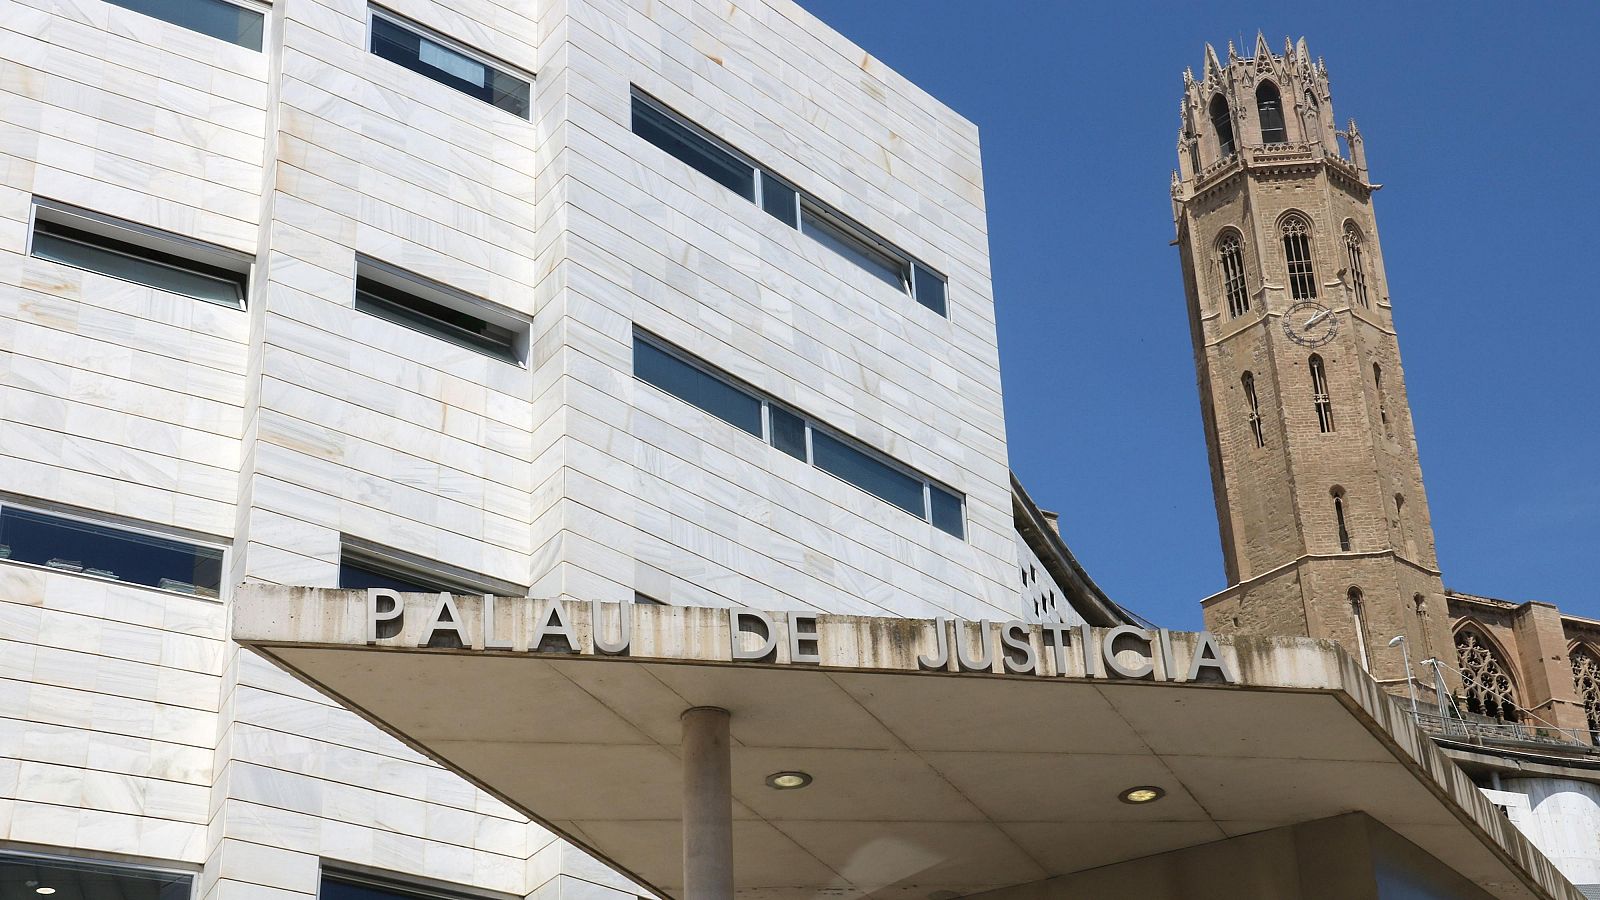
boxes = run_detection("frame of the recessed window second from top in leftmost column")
[24,194,256,311]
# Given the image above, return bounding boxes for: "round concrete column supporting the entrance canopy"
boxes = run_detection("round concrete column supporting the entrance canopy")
[683,706,733,900]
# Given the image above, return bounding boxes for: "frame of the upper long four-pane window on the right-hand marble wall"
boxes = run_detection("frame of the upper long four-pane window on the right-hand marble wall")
[629,85,950,320]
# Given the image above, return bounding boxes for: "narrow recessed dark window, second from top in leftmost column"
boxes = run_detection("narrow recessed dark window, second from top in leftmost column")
[32,199,250,307]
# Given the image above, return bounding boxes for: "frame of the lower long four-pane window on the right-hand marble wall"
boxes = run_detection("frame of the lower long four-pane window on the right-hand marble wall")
[634,327,971,541]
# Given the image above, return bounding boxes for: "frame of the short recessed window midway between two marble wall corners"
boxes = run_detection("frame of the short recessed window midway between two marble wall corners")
[350,253,533,370]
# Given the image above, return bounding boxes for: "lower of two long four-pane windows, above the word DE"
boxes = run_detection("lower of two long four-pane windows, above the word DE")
[634,331,966,540]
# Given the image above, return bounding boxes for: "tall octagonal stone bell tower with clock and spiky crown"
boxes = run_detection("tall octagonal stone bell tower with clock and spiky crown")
[1173,35,1454,697]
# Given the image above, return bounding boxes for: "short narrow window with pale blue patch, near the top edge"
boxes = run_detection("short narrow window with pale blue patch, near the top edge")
[371,8,533,119]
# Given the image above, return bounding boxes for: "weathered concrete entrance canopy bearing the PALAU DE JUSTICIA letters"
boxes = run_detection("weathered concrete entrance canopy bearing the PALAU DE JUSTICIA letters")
[235,588,1578,900]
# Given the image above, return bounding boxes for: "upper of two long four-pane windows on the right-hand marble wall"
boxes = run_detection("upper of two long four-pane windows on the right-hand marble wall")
[634,88,950,317]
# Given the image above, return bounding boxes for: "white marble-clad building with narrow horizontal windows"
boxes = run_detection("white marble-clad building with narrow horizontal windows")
[0,0,1075,900]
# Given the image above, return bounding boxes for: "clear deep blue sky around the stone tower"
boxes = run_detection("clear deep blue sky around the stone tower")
[802,0,1600,628]
